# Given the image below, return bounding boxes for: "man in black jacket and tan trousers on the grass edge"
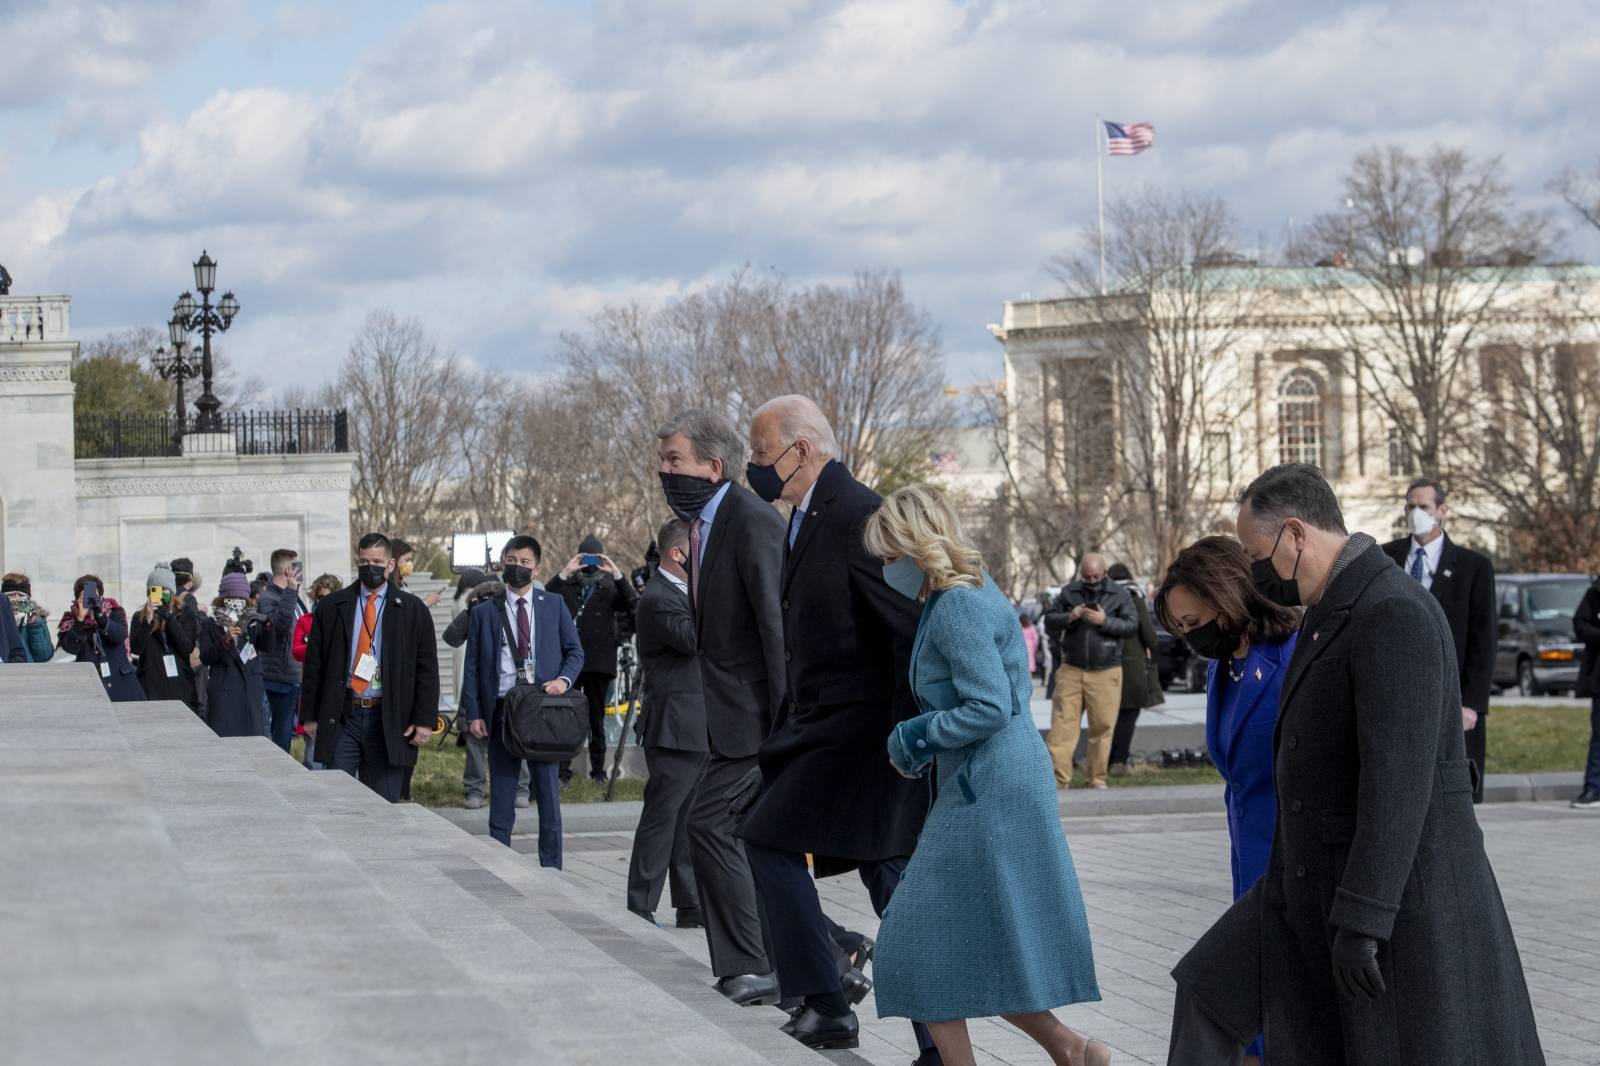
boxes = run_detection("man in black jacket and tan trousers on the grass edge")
[1045,554,1139,789]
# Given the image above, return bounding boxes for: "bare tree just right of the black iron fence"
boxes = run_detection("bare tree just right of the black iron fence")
[338,311,470,543]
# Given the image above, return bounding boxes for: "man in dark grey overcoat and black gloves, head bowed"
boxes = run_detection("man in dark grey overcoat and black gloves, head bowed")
[1168,464,1544,1066]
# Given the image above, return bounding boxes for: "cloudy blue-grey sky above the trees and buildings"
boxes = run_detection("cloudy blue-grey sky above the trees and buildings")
[0,0,1600,384]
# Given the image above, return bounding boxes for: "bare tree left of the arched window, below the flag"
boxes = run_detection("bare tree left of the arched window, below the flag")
[1046,187,1267,573]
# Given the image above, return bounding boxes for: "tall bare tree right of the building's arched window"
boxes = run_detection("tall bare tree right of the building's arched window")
[1294,146,1549,475]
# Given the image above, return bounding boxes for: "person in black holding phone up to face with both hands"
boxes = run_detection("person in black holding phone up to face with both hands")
[547,533,638,784]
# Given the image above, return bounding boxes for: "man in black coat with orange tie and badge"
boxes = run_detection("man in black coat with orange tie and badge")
[301,533,438,804]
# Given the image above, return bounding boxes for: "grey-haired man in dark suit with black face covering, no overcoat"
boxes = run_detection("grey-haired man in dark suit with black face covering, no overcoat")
[656,410,784,1005]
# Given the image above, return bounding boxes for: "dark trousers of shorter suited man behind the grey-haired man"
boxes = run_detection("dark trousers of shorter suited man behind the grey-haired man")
[627,747,706,911]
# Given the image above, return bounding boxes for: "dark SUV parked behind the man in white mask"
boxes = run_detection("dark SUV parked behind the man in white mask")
[1494,573,1590,696]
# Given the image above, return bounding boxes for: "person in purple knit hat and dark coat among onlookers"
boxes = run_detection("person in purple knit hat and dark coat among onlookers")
[200,570,277,736]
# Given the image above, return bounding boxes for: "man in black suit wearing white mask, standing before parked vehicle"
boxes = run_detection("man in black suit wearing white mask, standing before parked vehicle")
[1384,479,1499,804]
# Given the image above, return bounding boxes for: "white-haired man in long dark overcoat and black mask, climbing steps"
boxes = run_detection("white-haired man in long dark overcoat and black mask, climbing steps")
[739,395,933,1052]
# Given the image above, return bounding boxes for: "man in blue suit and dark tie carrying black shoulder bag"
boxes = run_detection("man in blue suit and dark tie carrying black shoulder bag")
[461,536,584,869]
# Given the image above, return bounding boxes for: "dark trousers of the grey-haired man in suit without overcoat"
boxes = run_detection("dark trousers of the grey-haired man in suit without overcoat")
[688,752,773,978]
